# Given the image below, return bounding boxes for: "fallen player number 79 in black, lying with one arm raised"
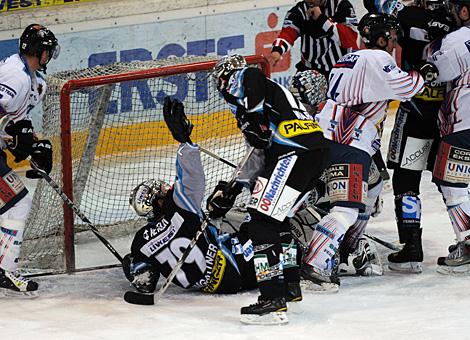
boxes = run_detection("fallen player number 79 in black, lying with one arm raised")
[123,97,302,310]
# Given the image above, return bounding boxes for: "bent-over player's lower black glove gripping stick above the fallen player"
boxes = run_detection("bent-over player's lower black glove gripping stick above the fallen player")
[206,181,243,218]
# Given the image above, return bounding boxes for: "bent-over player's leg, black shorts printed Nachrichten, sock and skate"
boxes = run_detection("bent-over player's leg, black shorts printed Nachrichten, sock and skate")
[241,147,323,324]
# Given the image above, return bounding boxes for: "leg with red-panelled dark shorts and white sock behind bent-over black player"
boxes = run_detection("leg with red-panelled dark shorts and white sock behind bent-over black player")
[301,143,371,291]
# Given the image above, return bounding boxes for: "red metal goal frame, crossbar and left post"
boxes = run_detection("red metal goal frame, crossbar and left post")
[60,55,271,273]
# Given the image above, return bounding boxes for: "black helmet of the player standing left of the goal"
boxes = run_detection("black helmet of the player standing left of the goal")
[20,24,60,71]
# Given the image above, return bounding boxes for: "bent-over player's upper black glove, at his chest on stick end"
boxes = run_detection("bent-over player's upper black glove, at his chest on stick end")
[236,112,272,149]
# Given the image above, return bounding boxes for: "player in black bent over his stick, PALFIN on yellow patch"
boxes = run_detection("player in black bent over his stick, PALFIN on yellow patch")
[208,55,325,324]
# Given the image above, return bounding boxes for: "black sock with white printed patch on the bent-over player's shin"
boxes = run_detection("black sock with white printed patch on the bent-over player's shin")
[253,244,284,299]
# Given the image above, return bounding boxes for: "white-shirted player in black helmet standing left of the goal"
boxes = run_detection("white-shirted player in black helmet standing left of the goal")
[0,24,60,295]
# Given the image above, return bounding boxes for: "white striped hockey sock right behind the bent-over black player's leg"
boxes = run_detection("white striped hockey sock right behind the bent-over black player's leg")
[304,207,358,275]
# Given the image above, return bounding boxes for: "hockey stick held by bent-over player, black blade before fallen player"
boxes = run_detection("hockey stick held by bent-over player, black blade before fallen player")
[124,147,255,305]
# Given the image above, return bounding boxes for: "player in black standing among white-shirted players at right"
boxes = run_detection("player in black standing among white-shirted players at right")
[364,0,454,273]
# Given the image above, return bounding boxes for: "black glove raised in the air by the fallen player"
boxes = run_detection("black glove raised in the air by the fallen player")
[163,96,194,143]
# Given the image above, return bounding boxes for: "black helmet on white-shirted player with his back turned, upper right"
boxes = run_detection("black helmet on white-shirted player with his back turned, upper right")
[358,13,401,48]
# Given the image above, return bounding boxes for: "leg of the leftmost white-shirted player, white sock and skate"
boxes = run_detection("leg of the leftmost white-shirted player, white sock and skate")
[0,152,38,294]
